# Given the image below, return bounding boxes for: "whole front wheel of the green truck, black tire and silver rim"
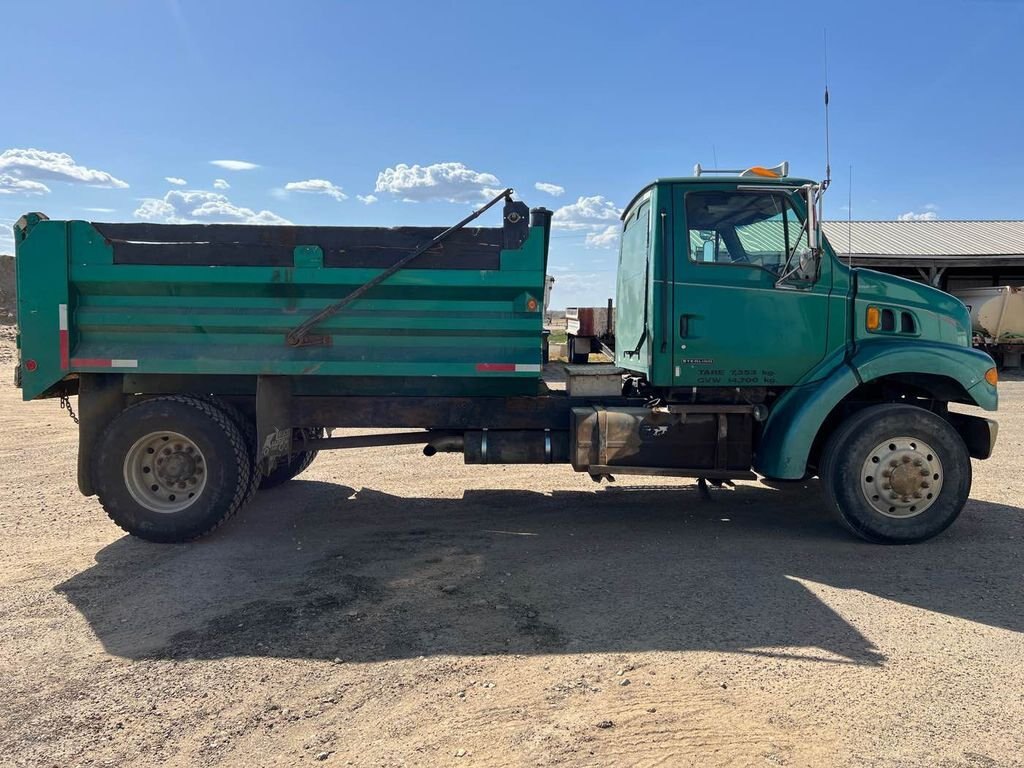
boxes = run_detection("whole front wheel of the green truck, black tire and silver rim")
[820,404,971,544]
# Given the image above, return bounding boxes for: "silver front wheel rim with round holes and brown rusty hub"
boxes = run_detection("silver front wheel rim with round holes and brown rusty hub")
[860,437,943,519]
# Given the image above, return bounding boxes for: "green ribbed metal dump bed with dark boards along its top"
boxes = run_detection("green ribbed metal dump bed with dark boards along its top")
[15,203,549,399]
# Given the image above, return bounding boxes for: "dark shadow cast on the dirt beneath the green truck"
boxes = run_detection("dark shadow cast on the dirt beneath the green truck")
[55,480,1024,665]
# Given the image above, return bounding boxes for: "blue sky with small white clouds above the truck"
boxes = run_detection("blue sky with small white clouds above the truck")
[0,0,1024,306]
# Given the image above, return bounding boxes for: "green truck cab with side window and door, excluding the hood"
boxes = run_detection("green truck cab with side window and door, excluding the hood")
[616,176,850,389]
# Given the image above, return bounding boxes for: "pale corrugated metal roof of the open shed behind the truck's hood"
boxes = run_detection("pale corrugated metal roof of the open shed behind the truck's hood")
[823,220,1024,290]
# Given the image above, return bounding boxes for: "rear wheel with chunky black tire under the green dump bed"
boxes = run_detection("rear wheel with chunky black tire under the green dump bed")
[92,395,253,542]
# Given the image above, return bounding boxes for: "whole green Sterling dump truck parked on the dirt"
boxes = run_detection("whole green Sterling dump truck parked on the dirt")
[14,167,997,543]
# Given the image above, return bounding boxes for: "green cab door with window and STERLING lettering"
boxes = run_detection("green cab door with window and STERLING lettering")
[672,183,831,387]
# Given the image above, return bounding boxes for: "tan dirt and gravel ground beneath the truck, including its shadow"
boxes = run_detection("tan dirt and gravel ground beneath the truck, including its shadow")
[0,334,1024,767]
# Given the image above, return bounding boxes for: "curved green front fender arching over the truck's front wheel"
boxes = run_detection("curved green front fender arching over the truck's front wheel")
[754,340,998,480]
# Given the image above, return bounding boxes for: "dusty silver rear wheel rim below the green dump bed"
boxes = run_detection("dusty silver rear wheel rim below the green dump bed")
[124,431,207,514]
